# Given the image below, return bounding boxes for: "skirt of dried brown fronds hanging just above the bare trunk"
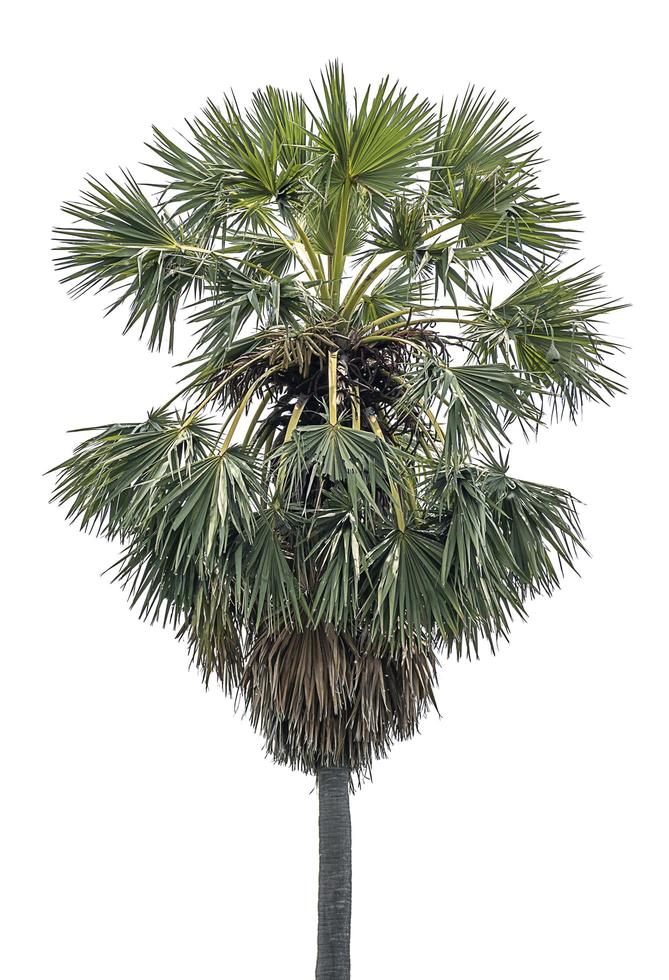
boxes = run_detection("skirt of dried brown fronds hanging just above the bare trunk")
[241,626,437,775]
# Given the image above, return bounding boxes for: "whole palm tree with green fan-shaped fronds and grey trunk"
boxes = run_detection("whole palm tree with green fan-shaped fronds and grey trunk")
[55,63,622,980]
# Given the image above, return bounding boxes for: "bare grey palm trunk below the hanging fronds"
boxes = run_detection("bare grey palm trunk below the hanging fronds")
[316,768,351,980]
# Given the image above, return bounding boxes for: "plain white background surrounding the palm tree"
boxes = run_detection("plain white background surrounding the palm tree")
[0,0,669,980]
